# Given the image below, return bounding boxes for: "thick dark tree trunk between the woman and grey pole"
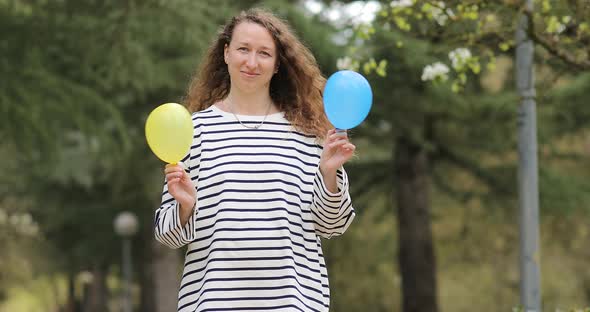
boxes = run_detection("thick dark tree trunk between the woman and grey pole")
[394,138,438,312]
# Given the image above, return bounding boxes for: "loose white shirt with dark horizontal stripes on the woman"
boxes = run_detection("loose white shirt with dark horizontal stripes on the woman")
[155,106,355,312]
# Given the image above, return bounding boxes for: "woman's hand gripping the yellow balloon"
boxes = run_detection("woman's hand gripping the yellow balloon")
[164,164,197,211]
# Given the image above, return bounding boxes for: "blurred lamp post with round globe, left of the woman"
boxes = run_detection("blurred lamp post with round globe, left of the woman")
[114,211,139,312]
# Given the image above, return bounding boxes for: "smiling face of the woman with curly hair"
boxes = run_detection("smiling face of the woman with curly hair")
[224,22,278,93]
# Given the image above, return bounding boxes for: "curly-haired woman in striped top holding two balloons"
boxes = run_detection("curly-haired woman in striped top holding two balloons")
[155,10,355,312]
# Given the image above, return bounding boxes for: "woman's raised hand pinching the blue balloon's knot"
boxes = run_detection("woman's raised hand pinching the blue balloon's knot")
[320,129,356,175]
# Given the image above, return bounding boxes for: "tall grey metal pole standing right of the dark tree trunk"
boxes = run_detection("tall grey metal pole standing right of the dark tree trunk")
[516,0,541,312]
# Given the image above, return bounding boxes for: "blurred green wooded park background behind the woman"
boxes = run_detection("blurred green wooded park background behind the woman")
[0,0,590,312]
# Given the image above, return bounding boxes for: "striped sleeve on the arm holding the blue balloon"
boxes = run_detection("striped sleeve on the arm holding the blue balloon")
[311,168,355,238]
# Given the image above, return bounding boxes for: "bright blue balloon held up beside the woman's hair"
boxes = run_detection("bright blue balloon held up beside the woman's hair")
[324,70,373,130]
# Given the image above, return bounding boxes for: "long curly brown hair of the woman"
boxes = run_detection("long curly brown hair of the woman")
[185,9,332,138]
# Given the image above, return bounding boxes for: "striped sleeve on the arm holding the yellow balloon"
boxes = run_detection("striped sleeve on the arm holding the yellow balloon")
[154,115,201,248]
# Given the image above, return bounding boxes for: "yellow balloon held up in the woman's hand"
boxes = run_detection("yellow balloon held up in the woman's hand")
[145,103,193,164]
